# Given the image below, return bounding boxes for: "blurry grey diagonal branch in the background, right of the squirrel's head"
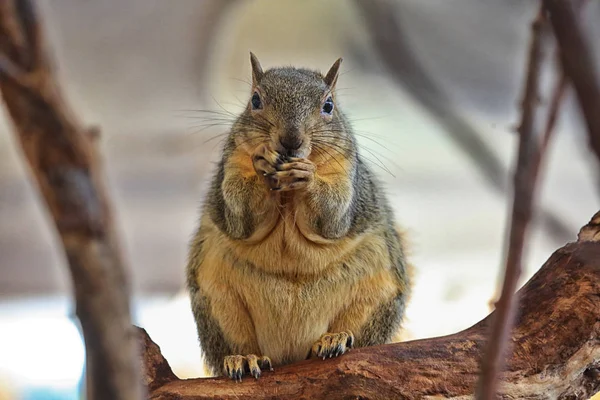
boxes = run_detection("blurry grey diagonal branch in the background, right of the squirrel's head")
[355,0,573,243]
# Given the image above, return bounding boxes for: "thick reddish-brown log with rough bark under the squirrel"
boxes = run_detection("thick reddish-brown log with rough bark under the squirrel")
[140,212,600,400]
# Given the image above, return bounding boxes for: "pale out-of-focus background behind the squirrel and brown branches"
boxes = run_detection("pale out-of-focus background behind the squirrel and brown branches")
[0,0,600,400]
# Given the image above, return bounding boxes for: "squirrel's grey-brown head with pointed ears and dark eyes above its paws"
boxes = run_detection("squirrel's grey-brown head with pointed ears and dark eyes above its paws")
[233,53,349,158]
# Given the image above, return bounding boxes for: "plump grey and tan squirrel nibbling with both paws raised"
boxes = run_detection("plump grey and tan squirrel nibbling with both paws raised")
[187,53,410,380]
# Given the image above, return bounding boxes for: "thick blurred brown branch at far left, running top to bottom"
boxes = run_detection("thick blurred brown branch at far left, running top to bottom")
[0,0,142,400]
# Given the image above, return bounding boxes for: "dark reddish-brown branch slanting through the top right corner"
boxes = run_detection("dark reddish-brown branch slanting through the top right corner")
[543,0,600,161]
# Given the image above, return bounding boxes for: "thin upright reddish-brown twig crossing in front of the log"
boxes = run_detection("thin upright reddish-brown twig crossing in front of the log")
[477,8,547,400]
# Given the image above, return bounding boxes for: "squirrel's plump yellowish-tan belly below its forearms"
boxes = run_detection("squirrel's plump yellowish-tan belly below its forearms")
[190,211,402,366]
